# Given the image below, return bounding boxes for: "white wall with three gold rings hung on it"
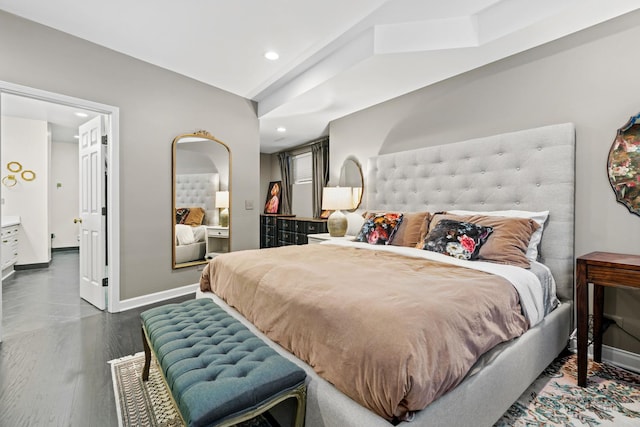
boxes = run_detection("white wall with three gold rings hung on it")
[0,117,50,265]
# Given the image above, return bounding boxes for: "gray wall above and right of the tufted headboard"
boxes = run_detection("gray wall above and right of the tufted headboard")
[330,11,640,353]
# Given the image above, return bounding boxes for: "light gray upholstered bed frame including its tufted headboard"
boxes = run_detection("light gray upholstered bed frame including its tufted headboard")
[198,123,575,427]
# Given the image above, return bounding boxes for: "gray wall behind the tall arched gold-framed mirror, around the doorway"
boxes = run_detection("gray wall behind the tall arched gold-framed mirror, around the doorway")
[0,11,261,301]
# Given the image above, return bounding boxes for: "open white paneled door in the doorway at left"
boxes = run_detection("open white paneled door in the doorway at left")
[78,115,107,310]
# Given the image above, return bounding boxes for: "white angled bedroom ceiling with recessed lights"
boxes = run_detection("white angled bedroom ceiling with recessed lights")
[0,0,640,153]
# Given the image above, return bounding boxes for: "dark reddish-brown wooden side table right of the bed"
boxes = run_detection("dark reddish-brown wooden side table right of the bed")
[576,252,640,387]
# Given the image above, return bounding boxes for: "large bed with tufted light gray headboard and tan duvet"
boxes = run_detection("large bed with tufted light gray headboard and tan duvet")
[198,124,575,426]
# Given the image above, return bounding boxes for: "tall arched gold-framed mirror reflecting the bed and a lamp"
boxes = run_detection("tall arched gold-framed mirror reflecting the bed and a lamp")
[171,131,231,269]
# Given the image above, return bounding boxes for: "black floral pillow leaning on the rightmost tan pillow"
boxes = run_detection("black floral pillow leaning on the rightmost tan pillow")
[422,219,493,260]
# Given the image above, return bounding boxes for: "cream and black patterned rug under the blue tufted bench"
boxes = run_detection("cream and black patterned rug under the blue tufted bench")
[109,353,273,427]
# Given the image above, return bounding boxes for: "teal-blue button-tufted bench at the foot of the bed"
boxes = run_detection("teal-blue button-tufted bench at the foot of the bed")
[141,298,306,427]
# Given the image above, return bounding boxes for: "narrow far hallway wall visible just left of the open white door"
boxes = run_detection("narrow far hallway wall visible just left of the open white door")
[49,141,80,248]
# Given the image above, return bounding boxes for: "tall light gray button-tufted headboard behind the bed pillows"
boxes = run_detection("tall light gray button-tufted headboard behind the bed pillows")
[365,123,575,301]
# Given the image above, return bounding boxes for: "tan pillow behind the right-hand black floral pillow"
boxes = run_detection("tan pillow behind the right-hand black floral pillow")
[416,213,540,268]
